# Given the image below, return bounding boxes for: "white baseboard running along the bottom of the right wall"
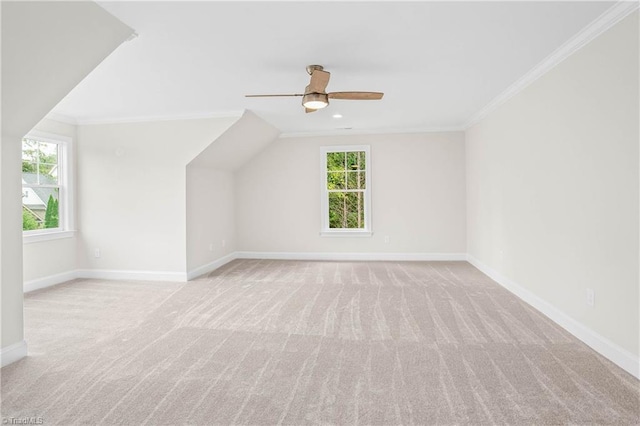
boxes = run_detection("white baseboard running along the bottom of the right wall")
[467,255,640,379]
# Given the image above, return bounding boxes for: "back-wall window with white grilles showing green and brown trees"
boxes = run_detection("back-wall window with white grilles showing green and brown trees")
[321,146,371,236]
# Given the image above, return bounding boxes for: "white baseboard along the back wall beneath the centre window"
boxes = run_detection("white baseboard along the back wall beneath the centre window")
[235,251,467,261]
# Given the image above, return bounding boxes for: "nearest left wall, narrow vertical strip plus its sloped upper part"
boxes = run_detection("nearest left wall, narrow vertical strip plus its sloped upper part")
[0,2,132,358]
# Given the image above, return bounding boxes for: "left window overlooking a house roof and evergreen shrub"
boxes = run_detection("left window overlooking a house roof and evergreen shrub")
[22,132,71,241]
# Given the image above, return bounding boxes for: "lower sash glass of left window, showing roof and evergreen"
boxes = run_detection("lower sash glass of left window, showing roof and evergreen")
[22,187,60,231]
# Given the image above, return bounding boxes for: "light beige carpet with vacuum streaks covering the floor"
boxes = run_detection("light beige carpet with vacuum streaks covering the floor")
[2,260,640,425]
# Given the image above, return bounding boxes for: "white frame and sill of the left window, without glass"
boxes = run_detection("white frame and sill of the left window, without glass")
[20,130,75,244]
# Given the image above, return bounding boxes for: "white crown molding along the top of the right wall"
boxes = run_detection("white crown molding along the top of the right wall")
[463,0,639,130]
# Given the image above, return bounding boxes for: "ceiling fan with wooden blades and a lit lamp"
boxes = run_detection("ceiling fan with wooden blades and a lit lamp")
[245,65,384,113]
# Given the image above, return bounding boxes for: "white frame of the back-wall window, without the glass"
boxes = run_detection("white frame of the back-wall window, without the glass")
[320,145,373,237]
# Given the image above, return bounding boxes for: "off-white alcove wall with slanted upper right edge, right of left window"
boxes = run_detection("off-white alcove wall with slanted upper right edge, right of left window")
[77,117,238,279]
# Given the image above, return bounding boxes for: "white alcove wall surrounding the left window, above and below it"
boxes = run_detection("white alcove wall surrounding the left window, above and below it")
[22,119,78,284]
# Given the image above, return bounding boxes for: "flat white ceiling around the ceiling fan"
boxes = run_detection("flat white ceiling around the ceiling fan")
[53,1,613,133]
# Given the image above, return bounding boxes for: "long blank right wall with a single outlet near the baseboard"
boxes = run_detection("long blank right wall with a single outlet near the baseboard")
[466,12,640,360]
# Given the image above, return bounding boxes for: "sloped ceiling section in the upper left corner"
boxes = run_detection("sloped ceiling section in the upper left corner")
[1,2,133,137]
